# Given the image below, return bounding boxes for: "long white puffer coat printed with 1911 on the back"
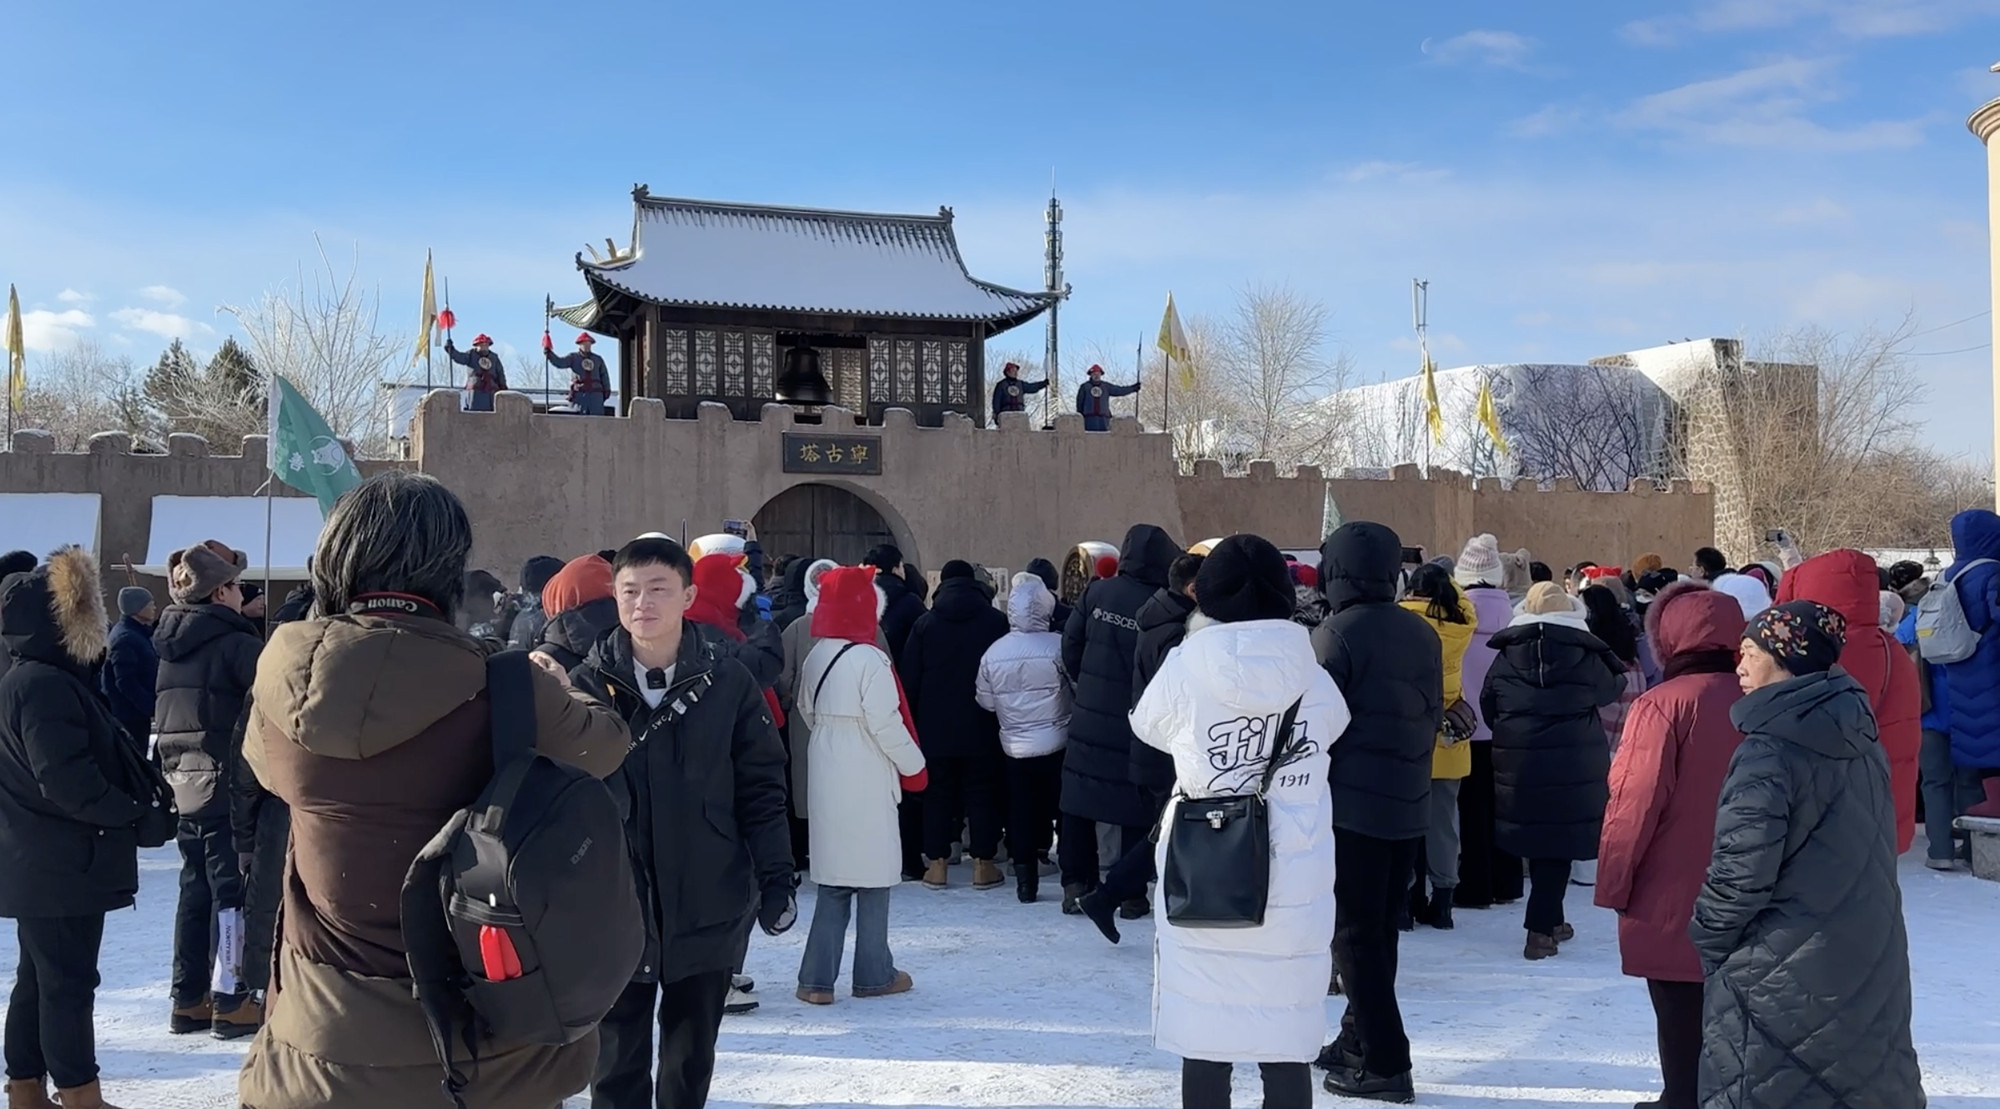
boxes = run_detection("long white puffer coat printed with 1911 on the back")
[1132,621,1350,1063]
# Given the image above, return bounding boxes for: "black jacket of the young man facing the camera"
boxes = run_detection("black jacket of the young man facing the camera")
[570,621,792,983]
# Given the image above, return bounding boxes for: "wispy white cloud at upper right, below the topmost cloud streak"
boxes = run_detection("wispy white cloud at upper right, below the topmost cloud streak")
[1618,58,1924,152]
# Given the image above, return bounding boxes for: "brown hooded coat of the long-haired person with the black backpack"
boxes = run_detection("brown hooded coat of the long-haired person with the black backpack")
[238,615,630,1109]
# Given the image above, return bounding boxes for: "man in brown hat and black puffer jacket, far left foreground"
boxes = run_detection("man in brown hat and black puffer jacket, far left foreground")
[152,540,264,1039]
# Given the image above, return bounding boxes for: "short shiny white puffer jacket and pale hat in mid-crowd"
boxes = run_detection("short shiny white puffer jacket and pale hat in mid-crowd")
[974,575,1072,759]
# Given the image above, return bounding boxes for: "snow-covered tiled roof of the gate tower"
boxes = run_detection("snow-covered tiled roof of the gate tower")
[564,192,1050,326]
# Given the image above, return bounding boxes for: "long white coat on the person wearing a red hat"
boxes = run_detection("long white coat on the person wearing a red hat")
[796,639,924,889]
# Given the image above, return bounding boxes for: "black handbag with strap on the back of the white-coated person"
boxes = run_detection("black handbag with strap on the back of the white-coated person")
[1160,699,1304,929]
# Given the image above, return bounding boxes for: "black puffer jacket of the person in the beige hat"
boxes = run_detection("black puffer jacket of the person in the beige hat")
[1478,617,1626,859]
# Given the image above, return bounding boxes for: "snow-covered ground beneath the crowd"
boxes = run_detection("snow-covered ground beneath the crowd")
[0,849,2000,1109]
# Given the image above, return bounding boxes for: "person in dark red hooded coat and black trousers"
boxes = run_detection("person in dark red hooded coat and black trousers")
[1596,583,1744,1109]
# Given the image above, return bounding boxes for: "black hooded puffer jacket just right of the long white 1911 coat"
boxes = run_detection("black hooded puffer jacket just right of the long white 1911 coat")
[1312,522,1444,839]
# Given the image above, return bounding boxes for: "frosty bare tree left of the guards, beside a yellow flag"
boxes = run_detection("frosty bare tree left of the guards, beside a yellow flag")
[220,236,404,456]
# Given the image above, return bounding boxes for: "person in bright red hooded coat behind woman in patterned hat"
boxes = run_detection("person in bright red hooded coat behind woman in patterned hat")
[1778,550,1924,855]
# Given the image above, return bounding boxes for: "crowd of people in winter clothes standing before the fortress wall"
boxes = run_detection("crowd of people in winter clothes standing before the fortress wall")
[0,468,2000,1109]
